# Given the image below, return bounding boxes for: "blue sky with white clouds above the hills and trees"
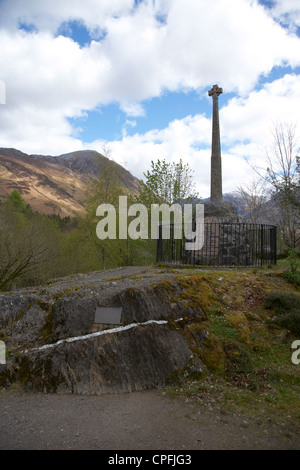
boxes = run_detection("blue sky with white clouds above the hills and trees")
[0,0,300,197]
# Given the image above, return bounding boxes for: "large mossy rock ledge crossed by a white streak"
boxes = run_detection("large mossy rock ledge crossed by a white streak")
[0,268,223,395]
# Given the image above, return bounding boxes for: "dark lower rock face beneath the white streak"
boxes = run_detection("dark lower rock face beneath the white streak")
[17,324,191,394]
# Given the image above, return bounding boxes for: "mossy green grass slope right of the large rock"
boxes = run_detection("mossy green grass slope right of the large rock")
[164,260,300,425]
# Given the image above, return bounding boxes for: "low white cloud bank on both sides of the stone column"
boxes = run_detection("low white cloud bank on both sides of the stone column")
[86,75,300,197]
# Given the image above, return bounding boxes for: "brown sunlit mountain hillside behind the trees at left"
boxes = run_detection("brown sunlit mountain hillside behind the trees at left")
[0,148,138,217]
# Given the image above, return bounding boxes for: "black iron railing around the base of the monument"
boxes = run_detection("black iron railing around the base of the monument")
[156,222,276,266]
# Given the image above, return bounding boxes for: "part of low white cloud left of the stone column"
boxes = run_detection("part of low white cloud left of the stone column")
[86,115,218,197]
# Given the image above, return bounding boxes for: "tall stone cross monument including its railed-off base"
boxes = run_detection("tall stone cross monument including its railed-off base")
[160,85,276,266]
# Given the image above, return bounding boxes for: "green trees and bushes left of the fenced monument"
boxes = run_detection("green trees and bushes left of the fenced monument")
[0,159,202,290]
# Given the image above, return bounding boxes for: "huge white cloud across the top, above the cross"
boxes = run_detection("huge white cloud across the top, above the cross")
[0,0,300,109]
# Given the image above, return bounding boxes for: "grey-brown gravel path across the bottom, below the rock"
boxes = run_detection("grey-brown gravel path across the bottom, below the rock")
[0,390,300,450]
